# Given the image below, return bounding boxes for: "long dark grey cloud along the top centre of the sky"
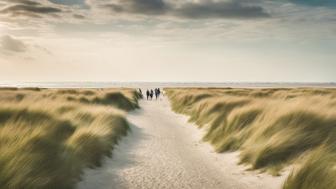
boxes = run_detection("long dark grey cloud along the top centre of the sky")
[99,0,270,19]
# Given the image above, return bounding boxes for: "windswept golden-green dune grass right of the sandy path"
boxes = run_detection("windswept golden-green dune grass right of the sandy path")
[166,88,336,189]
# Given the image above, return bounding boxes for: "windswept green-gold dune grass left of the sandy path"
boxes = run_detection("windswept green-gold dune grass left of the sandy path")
[0,88,139,189]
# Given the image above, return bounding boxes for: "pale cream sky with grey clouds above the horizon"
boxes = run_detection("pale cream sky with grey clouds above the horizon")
[0,0,336,82]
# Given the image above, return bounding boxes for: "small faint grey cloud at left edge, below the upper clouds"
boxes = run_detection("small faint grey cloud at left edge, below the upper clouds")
[0,35,27,52]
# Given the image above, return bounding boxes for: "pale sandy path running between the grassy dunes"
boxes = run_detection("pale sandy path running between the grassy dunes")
[78,96,285,189]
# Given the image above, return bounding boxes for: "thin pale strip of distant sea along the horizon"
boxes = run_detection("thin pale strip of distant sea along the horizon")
[0,82,336,88]
